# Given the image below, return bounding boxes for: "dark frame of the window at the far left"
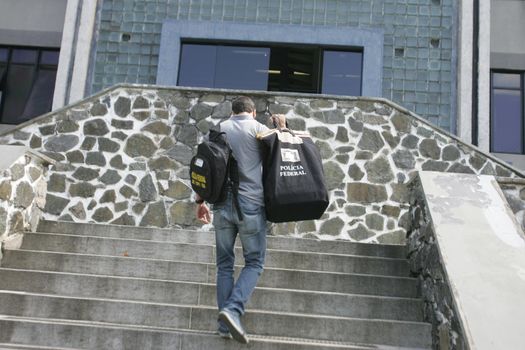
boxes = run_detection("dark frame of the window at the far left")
[0,44,60,125]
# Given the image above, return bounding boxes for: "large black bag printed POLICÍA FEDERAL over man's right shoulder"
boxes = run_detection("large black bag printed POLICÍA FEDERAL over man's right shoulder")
[257,129,328,222]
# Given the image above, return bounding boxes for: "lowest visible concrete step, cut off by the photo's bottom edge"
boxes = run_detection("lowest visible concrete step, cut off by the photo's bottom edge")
[0,317,430,350]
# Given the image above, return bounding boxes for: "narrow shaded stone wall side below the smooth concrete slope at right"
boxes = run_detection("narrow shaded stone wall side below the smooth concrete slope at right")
[407,177,468,350]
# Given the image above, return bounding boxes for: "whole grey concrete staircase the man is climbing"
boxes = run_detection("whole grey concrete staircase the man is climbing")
[0,221,431,350]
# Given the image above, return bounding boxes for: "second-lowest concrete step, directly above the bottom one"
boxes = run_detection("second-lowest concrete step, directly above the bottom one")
[0,292,431,347]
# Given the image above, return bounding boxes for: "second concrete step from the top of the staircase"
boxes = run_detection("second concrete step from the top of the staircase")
[22,233,409,276]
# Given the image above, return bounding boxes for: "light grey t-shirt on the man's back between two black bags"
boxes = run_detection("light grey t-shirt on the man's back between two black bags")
[220,114,268,206]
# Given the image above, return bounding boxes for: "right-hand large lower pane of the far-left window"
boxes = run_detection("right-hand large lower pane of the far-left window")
[21,69,56,120]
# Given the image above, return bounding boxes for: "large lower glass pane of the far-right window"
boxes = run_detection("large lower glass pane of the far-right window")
[492,89,523,153]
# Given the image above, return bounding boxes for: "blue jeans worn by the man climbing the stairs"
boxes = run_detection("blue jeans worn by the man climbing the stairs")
[213,193,267,315]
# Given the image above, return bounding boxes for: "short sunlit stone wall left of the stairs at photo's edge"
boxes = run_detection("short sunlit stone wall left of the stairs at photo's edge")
[0,153,50,258]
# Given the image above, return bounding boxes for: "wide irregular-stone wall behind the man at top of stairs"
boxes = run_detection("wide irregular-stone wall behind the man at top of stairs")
[0,86,521,244]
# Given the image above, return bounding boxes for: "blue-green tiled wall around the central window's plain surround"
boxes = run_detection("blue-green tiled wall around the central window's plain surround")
[91,0,457,131]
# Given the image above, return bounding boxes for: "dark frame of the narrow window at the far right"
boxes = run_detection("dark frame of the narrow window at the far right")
[489,69,525,155]
